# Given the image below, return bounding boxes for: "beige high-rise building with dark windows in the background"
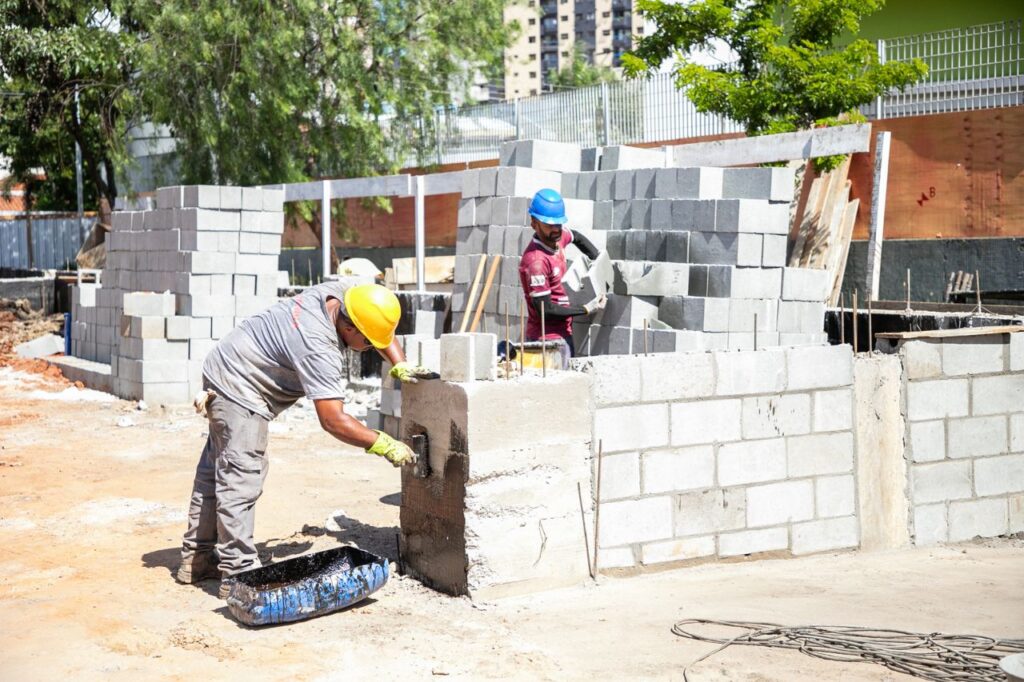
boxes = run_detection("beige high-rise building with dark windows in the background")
[504,0,644,99]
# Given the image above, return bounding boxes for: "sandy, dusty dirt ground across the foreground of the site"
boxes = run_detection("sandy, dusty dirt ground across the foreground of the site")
[0,368,1024,682]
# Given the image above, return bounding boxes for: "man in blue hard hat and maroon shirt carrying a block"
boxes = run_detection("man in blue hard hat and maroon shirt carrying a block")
[519,188,606,355]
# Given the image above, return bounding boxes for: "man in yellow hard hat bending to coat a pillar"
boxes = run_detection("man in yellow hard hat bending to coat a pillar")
[175,280,437,598]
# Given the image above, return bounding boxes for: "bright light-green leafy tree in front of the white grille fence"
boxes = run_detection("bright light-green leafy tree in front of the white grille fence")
[623,0,927,168]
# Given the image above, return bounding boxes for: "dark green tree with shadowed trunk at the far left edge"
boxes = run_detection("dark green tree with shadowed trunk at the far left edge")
[0,0,137,210]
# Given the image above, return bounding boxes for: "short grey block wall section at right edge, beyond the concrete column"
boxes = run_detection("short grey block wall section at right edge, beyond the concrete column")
[899,333,1024,545]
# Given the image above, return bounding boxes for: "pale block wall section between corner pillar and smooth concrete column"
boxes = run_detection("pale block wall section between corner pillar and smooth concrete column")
[573,346,860,568]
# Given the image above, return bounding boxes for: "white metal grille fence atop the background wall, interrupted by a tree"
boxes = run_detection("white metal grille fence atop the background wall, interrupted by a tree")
[425,19,1024,164]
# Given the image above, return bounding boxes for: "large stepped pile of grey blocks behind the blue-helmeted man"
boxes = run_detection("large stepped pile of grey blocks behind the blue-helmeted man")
[453,140,828,355]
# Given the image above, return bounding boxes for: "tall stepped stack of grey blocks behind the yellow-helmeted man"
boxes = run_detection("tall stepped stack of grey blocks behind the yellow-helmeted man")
[72,185,285,403]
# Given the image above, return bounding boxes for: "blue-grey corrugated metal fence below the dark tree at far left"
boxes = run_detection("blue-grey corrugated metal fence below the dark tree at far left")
[0,216,96,269]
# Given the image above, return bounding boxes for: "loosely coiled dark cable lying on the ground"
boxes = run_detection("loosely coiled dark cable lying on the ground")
[672,619,1024,682]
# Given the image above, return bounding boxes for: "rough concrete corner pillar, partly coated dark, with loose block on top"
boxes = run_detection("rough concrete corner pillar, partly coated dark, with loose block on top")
[400,334,592,599]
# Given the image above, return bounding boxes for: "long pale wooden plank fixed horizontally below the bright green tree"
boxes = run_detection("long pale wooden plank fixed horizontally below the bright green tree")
[669,123,871,167]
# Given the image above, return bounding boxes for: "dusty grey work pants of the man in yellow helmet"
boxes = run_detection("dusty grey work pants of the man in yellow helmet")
[181,395,269,576]
